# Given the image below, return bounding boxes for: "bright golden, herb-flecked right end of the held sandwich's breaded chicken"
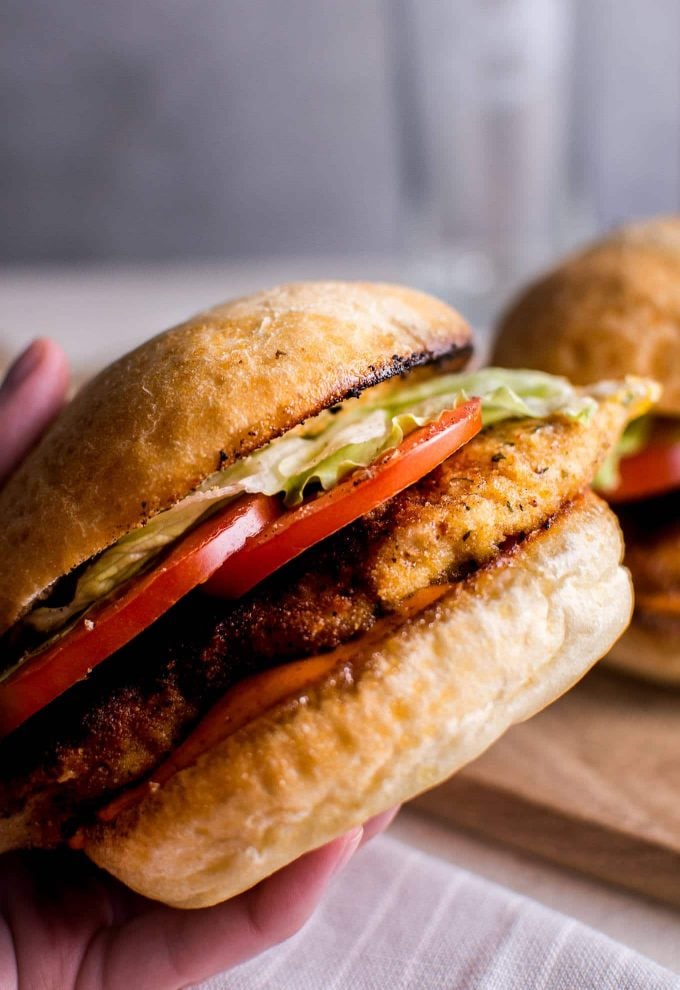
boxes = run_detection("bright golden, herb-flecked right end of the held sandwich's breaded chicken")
[365,400,627,606]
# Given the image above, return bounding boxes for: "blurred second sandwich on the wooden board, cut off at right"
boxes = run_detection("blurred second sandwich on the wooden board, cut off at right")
[494,216,680,684]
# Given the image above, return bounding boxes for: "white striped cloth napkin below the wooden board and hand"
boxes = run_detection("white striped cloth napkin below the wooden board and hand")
[189,836,680,990]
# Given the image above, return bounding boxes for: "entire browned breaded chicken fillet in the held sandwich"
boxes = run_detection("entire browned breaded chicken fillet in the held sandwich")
[0,401,627,843]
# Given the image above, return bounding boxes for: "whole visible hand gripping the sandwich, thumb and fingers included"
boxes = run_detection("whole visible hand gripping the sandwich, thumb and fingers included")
[0,340,396,990]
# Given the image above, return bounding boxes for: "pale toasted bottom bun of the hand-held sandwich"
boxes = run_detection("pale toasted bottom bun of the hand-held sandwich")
[86,493,632,908]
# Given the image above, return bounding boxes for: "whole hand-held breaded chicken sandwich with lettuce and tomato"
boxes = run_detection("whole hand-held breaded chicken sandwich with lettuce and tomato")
[0,282,654,907]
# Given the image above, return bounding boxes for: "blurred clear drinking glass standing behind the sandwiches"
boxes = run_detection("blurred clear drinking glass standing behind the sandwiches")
[393,0,588,334]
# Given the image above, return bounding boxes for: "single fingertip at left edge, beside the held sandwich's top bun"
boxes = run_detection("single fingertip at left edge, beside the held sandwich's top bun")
[0,339,69,482]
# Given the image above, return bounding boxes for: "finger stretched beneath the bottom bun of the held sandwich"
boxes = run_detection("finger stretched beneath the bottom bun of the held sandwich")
[78,828,363,990]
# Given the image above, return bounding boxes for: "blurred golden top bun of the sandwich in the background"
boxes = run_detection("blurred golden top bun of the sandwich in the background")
[493,217,680,415]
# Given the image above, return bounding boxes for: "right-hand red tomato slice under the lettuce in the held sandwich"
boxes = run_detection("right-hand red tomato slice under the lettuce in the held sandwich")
[203,399,482,598]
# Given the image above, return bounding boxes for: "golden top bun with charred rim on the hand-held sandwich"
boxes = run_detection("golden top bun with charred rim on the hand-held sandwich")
[0,282,470,633]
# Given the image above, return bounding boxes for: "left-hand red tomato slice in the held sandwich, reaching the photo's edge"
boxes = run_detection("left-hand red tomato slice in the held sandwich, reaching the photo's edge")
[0,495,281,737]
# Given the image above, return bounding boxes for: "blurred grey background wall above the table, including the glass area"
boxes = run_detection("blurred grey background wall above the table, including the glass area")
[0,0,680,282]
